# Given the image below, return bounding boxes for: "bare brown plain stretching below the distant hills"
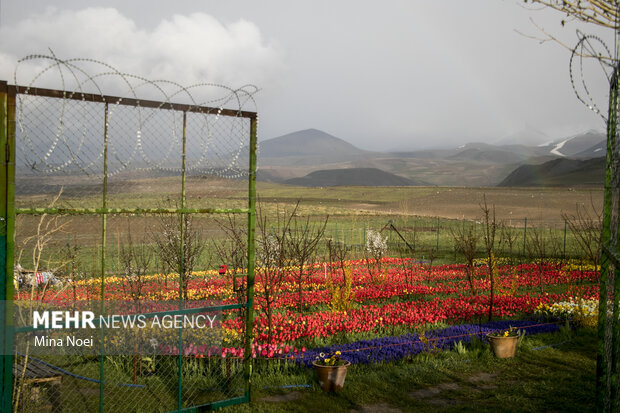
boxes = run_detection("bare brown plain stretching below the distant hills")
[17,177,603,245]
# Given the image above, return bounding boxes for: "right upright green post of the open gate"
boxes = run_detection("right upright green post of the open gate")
[243,117,258,403]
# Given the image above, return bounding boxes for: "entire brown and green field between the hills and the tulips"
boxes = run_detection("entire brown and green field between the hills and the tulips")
[16,181,603,273]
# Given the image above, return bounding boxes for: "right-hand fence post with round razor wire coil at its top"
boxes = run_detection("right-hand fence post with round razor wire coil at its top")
[570,21,620,412]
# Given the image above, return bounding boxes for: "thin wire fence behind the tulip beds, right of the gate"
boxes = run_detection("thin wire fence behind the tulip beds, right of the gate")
[318,212,602,262]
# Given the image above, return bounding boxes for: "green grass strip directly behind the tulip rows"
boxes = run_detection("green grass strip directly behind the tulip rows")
[16,204,596,274]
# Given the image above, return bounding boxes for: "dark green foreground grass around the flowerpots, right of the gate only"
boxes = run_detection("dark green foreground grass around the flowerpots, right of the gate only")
[222,329,596,412]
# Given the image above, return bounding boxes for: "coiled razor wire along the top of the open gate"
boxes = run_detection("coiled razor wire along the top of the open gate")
[13,51,258,178]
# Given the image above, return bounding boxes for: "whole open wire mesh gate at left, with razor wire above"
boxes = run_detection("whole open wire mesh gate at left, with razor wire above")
[2,56,257,412]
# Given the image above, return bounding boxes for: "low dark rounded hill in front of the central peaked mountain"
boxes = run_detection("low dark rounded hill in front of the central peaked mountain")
[283,168,423,187]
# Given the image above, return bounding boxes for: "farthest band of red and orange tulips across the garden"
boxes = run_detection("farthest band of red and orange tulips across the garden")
[16,258,598,308]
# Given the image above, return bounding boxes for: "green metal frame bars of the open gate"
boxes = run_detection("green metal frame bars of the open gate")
[0,81,258,412]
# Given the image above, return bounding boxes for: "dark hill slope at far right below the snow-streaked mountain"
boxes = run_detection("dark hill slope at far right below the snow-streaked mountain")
[498,157,605,187]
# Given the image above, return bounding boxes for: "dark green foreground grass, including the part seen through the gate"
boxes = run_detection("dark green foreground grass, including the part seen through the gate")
[15,328,596,413]
